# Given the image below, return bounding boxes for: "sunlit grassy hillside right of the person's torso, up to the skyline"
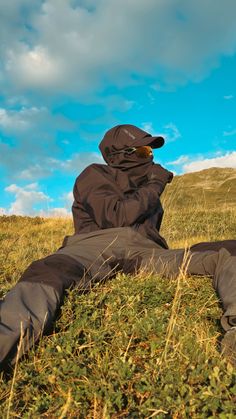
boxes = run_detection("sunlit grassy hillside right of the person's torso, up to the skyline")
[161,168,236,248]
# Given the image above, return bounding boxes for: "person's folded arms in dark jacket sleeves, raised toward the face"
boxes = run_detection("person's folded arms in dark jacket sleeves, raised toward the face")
[74,167,170,228]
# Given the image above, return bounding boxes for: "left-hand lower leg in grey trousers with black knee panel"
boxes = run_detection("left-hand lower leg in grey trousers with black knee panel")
[0,254,87,367]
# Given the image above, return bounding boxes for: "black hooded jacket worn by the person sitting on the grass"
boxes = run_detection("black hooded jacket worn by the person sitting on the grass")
[72,126,173,248]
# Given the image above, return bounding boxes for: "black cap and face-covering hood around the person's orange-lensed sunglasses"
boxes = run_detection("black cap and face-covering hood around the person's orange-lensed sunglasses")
[99,125,164,170]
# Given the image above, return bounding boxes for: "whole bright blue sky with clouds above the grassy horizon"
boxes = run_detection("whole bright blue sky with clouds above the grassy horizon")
[0,0,236,216]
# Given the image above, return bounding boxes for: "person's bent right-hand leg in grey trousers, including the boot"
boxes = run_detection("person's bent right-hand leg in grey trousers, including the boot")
[131,241,236,367]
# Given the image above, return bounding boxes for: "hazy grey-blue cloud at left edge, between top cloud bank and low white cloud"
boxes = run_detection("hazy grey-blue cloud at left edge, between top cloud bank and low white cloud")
[0,106,75,180]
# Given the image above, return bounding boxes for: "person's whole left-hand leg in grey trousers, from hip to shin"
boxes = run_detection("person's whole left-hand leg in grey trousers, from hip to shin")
[0,229,133,367]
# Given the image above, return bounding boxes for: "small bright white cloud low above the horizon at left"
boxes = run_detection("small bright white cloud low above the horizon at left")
[5,183,51,215]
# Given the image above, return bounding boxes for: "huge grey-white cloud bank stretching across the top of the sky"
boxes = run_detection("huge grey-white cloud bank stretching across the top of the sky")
[0,0,236,96]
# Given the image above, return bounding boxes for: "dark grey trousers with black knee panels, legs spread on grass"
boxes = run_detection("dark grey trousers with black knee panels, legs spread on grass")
[0,227,236,365]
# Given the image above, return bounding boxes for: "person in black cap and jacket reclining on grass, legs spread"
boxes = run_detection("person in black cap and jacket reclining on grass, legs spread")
[0,125,236,368]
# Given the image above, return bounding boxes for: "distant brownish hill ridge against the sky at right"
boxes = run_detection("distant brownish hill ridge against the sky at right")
[163,167,236,209]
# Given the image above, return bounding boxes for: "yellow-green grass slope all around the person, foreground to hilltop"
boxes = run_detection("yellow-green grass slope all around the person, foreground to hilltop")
[0,169,236,419]
